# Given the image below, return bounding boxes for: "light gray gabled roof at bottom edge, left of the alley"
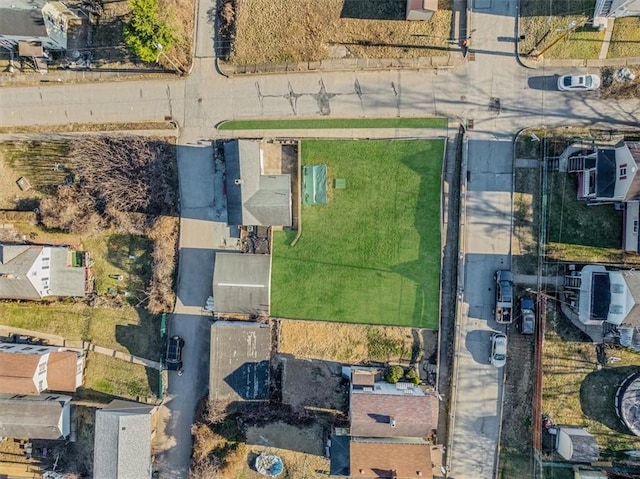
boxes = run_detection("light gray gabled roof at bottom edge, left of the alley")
[93,400,154,479]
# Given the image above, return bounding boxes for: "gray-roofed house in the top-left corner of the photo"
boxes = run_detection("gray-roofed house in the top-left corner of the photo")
[0,0,81,50]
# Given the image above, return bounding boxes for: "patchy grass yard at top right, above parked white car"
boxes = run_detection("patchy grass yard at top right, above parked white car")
[519,0,605,58]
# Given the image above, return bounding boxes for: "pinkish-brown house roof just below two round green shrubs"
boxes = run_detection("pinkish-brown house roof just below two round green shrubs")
[349,383,438,437]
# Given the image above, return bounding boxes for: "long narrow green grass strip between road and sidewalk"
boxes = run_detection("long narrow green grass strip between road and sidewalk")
[218,118,447,130]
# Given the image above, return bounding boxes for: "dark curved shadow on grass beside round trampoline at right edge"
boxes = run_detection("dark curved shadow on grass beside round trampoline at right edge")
[580,366,640,434]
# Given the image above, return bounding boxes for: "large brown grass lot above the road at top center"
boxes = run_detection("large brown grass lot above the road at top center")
[230,0,452,64]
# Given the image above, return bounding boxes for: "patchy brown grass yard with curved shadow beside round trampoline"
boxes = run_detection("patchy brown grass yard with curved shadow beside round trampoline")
[542,311,640,455]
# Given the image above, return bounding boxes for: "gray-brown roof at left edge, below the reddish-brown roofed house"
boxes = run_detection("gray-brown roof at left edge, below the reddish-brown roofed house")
[0,394,71,439]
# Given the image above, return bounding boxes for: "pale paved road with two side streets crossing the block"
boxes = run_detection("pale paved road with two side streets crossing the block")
[0,0,640,479]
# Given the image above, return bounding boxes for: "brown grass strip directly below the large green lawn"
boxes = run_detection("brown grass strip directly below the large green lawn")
[278,320,413,363]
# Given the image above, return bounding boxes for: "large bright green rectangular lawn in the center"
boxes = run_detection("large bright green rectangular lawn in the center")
[271,140,444,328]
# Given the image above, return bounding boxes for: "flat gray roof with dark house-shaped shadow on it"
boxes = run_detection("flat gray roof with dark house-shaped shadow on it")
[209,321,271,401]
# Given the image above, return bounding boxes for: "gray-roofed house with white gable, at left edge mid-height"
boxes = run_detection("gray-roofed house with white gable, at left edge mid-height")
[0,244,90,300]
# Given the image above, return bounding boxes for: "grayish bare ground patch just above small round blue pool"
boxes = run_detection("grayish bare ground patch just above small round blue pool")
[247,422,325,456]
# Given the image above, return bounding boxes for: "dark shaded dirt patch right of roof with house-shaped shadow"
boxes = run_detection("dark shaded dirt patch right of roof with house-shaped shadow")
[276,355,348,412]
